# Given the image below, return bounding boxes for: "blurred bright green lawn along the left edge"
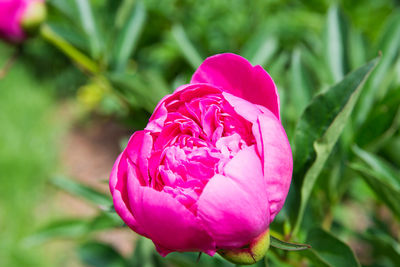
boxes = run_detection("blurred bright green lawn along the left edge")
[0,44,60,266]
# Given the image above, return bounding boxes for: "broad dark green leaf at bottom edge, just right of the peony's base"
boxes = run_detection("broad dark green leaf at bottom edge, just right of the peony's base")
[300,228,360,267]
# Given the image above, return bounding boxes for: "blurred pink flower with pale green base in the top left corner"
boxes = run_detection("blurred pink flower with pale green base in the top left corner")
[0,0,46,43]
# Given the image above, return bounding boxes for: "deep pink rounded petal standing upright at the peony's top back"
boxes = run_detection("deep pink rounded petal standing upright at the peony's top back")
[191,53,280,119]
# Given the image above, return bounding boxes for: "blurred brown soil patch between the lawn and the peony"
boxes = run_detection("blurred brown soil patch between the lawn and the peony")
[55,104,136,255]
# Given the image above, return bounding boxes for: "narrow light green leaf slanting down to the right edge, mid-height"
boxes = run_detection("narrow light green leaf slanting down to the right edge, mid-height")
[353,146,400,191]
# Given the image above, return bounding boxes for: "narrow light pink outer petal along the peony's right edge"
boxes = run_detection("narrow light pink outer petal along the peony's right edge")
[253,112,293,221]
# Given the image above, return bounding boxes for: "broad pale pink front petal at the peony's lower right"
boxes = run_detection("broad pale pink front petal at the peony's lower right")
[198,146,269,248]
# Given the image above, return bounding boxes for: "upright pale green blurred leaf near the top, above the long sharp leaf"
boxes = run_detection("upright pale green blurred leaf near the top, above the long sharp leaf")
[324,5,348,82]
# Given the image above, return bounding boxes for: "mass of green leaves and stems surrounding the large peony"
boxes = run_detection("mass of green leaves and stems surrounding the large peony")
[0,0,400,266]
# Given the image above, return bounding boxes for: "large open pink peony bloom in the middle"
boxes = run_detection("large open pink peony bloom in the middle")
[110,54,292,262]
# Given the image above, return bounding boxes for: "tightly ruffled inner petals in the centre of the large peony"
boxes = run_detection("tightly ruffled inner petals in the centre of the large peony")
[150,94,255,214]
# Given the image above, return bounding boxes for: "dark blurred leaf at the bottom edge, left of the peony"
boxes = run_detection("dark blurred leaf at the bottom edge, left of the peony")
[77,241,128,267]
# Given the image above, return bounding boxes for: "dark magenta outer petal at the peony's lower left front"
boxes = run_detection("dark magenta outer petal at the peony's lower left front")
[127,160,216,256]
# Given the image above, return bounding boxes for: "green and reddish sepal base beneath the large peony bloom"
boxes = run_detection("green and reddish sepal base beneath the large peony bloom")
[217,230,269,265]
